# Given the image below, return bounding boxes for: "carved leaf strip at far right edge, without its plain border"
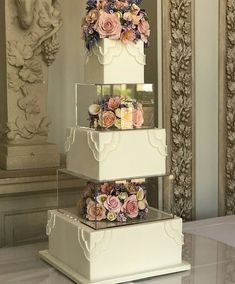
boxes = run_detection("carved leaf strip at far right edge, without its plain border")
[225,0,235,214]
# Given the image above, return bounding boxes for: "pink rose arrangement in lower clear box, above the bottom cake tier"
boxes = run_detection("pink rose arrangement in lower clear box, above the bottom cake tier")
[77,179,148,223]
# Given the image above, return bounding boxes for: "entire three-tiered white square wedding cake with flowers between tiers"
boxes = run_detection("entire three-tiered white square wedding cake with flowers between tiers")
[40,0,190,284]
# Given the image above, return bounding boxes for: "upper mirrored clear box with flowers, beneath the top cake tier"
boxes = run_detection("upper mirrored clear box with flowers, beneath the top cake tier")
[76,84,156,130]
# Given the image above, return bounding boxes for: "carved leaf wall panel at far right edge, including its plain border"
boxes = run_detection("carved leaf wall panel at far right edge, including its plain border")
[219,0,235,215]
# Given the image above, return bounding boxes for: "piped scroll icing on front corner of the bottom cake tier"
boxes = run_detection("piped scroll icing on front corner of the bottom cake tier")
[78,228,112,262]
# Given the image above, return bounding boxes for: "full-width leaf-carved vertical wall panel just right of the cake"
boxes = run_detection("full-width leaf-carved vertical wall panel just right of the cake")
[162,0,195,221]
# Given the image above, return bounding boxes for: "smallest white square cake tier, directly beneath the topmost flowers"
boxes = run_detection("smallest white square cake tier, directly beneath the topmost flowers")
[85,38,146,84]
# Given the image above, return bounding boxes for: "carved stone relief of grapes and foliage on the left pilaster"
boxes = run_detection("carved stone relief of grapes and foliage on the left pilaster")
[5,0,62,141]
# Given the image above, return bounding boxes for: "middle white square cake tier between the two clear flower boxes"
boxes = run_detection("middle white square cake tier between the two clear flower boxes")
[65,127,167,181]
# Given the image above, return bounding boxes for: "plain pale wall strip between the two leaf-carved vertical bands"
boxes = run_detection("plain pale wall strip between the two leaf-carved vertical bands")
[195,0,219,218]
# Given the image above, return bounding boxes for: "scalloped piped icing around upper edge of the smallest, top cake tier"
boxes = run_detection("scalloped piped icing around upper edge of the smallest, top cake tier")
[90,40,146,65]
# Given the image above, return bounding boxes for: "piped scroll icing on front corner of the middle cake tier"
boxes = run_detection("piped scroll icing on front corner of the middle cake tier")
[87,131,120,162]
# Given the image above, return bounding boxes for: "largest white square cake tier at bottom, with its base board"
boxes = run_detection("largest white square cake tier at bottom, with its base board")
[41,210,190,283]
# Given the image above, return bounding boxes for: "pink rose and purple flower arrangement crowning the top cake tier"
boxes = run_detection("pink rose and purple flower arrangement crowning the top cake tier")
[82,0,150,50]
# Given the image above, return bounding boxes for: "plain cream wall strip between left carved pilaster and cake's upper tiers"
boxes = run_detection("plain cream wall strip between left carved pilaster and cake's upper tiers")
[48,0,85,152]
